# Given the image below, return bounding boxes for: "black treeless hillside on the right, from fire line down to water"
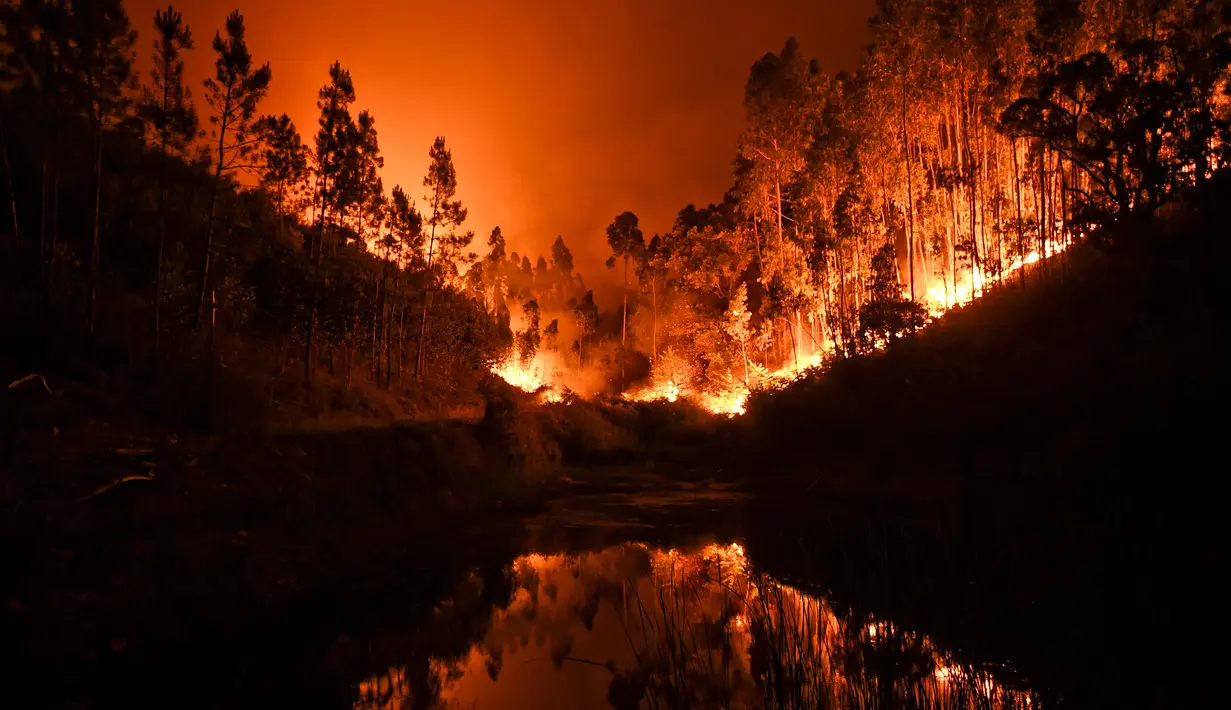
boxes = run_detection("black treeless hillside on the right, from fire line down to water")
[745,186,1229,708]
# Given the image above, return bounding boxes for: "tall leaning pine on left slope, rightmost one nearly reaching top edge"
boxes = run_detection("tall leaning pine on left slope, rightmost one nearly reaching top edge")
[197,10,273,325]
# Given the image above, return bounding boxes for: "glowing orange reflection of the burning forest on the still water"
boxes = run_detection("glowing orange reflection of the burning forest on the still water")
[356,544,1034,709]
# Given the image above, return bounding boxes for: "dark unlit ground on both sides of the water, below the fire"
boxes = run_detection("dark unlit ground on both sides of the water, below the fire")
[0,196,1227,706]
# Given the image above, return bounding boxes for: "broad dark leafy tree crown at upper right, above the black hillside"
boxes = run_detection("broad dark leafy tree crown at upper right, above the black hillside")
[1002,24,1231,222]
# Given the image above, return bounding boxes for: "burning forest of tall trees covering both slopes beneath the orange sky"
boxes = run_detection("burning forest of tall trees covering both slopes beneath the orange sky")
[0,0,1231,425]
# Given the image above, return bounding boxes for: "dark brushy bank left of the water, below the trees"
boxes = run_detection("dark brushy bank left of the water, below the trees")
[0,361,738,706]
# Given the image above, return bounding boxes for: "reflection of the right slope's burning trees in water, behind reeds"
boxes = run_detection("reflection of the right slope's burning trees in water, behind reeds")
[613,545,1034,710]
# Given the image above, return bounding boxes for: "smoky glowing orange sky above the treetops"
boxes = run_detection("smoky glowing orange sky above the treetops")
[127,0,873,300]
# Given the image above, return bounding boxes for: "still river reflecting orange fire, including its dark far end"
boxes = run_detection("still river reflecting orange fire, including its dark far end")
[345,472,1039,710]
